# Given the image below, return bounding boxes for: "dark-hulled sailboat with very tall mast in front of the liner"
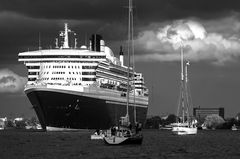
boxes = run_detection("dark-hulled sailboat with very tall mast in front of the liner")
[103,0,143,145]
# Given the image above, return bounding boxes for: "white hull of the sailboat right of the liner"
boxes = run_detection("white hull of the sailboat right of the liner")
[172,126,197,135]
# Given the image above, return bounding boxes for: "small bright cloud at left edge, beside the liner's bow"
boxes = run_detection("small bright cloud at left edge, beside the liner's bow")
[0,69,27,93]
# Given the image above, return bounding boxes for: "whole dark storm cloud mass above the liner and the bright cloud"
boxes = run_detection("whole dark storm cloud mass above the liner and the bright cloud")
[0,0,240,63]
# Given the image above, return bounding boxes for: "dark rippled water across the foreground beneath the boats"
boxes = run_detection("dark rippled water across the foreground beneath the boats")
[0,130,240,159]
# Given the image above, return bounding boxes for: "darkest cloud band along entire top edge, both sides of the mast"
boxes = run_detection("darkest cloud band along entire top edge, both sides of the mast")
[0,0,240,22]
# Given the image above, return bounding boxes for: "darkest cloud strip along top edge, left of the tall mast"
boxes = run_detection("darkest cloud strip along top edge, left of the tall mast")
[0,0,124,19]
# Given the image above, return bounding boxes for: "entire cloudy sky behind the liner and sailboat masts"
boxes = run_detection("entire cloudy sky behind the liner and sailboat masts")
[0,0,240,117]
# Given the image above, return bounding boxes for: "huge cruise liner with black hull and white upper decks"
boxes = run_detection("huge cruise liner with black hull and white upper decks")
[18,23,148,130]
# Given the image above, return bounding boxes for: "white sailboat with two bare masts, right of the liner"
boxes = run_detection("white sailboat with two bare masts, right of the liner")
[172,44,197,135]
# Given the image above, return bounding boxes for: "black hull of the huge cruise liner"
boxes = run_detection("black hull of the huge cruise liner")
[26,90,147,129]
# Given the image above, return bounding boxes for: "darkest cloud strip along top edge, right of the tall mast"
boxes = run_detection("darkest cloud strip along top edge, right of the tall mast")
[136,0,240,22]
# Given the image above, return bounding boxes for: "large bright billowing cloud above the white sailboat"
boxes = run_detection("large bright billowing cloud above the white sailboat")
[136,20,240,65]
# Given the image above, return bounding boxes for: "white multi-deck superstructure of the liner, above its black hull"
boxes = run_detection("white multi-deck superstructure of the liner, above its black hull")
[18,24,148,96]
